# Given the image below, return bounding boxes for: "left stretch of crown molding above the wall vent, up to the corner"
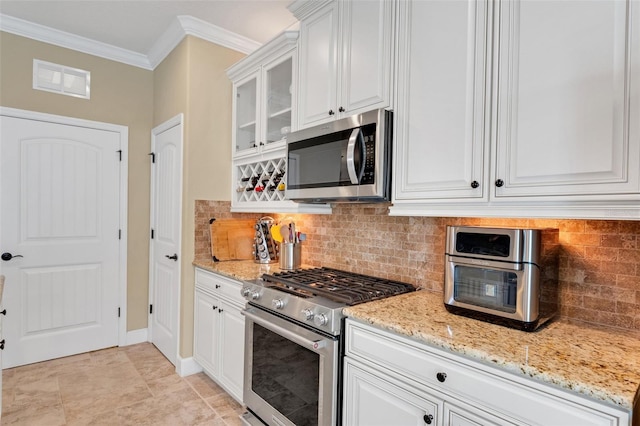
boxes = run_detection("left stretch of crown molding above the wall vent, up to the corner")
[0,14,152,70]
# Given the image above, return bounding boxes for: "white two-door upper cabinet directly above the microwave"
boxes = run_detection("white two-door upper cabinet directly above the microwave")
[289,0,395,128]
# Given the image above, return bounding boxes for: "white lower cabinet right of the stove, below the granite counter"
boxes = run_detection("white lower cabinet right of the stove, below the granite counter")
[343,319,631,426]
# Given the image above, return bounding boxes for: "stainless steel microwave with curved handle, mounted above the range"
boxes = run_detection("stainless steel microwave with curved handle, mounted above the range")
[286,109,393,203]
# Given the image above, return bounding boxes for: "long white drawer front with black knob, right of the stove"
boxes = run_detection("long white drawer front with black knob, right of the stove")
[345,320,629,426]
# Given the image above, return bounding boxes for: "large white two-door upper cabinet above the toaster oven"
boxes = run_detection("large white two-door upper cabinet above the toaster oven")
[391,0,640,219]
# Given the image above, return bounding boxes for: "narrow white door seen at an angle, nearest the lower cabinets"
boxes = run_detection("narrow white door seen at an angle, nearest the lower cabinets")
[149,115,182,365]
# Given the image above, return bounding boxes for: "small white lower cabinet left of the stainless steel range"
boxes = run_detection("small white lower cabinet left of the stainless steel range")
[193,268,244,403]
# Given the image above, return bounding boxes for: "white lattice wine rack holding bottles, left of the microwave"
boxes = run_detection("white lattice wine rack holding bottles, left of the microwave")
[236,158,287,203]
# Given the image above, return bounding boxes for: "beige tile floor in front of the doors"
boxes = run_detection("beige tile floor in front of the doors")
[1,343,243,426]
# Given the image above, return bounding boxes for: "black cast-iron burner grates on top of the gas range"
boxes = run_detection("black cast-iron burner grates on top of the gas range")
[262,268,415,306]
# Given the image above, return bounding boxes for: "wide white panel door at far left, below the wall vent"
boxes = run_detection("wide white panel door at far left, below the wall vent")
[0,116,123,368]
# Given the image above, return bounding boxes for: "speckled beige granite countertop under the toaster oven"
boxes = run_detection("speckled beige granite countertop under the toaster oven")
[344,291,640,411]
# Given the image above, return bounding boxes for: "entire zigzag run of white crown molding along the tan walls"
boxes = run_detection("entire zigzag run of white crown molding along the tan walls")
[0,14,261,70]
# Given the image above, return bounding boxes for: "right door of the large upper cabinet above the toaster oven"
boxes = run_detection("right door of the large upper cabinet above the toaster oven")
[492,0,640,197]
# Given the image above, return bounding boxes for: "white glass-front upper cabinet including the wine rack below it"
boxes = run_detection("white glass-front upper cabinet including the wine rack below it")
[227,31,331,213]
